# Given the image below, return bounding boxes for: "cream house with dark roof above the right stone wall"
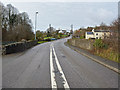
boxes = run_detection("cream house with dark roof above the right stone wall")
[85,29,110,39]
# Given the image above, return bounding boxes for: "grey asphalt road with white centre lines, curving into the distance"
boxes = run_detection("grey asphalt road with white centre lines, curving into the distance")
[2,39,118,88]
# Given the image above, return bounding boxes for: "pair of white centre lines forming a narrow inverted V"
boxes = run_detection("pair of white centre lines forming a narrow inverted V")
[50,44,70,89]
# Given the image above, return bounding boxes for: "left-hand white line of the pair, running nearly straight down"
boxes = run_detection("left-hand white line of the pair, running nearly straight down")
[50,45,57,90]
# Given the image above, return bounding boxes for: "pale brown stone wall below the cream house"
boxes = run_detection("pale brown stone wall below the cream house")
[68,39,94,50]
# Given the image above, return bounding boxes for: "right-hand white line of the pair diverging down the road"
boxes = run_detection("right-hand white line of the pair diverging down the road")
[52,45,70,90]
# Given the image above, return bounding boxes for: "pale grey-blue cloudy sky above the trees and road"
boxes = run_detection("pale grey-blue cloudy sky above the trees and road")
[1,0,118,31]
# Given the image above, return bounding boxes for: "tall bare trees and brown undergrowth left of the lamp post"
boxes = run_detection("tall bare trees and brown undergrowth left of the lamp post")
[0,3,34,42]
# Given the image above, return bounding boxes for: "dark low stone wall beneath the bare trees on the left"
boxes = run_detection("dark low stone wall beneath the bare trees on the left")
[2,41,37,55]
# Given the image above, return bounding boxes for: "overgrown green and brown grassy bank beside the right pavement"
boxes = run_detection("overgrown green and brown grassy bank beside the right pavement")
[93,39,120,63]
